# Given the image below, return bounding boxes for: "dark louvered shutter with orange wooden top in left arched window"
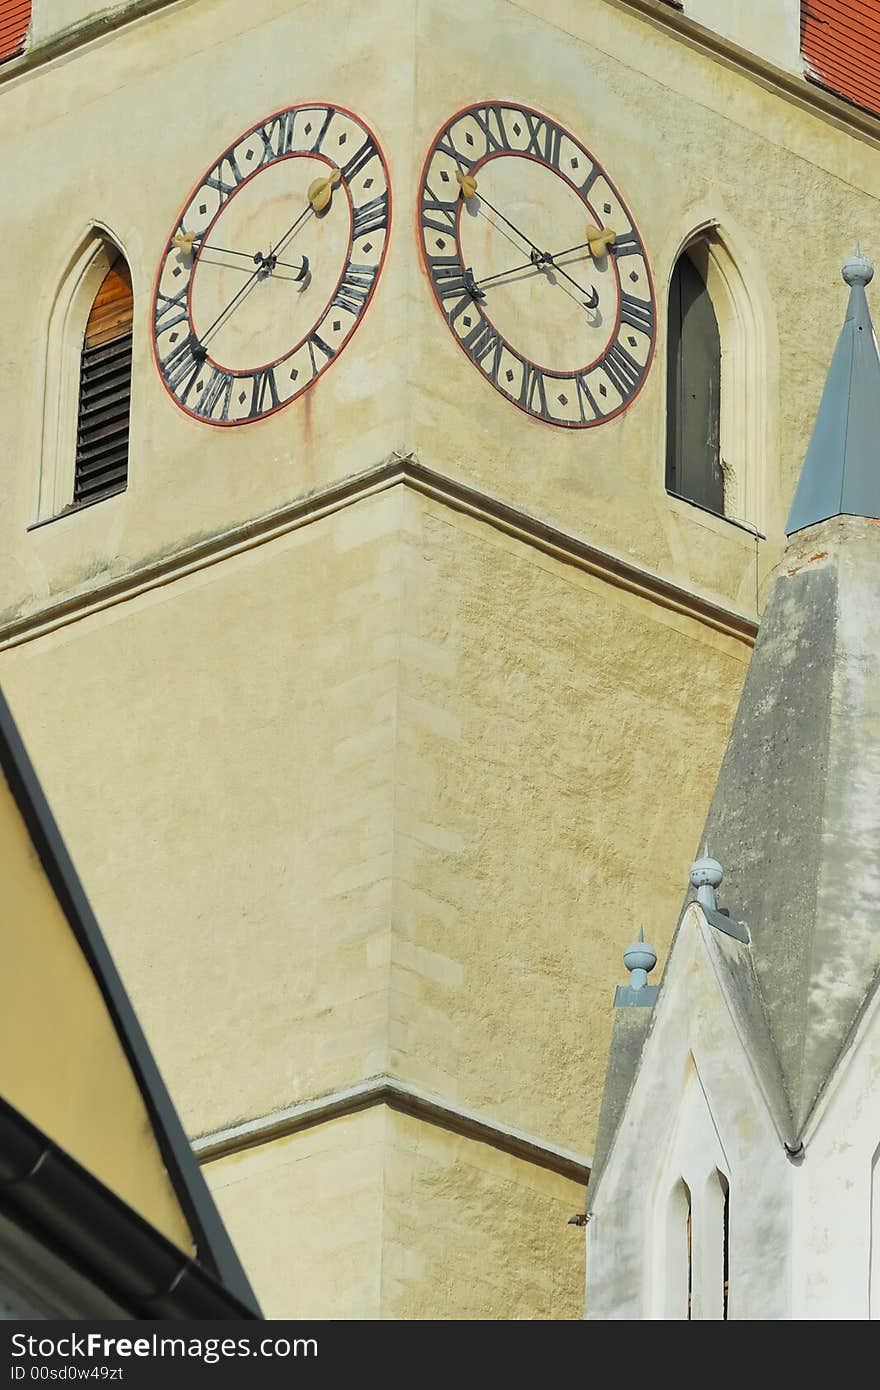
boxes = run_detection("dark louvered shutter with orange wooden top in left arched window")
[74,257,133,506]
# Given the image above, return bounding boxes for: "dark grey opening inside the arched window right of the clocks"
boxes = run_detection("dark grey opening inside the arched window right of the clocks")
[666,252,724,516]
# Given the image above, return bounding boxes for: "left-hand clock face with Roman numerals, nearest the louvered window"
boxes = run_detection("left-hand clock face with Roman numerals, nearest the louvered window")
[153,104,391,425]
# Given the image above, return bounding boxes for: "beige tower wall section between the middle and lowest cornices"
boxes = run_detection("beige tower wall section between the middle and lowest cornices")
[0,487,748,1154]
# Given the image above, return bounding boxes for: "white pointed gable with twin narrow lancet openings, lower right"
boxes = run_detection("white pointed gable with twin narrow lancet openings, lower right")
[587,905,795,1319]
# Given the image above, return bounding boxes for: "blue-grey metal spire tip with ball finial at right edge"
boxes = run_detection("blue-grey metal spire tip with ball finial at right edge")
[785,247,880,535]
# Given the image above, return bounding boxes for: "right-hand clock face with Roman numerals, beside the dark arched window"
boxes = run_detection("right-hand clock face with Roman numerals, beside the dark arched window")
[418,101,656,428]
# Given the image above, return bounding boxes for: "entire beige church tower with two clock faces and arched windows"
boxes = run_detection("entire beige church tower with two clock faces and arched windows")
[0,0,880,1318]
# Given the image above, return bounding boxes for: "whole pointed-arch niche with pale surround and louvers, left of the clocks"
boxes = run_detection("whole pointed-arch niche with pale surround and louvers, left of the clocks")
[35,225,133,524]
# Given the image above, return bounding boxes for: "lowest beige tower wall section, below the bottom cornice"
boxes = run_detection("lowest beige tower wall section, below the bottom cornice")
[204,1106,584,1322]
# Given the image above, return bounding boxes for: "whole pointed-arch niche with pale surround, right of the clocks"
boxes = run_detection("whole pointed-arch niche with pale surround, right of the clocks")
[666,222,767,530]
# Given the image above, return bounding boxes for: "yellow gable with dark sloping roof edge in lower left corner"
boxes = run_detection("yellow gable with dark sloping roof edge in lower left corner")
[0,695,260,1318]
